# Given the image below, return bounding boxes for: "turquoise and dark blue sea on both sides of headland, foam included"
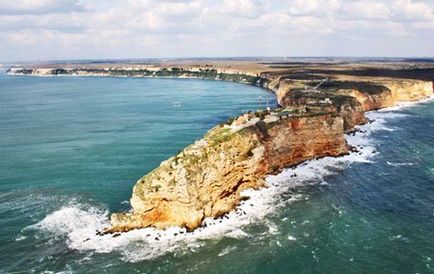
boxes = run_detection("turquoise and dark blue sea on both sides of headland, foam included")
[0,75,434,273]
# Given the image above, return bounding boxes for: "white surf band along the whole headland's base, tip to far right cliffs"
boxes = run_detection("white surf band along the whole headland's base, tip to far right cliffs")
[28,96,432,262]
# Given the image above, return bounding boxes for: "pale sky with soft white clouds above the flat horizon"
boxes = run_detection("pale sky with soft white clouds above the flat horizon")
[0,0,434,62]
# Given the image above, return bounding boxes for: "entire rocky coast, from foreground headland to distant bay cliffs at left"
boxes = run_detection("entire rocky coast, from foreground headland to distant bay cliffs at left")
[8,61,433,233]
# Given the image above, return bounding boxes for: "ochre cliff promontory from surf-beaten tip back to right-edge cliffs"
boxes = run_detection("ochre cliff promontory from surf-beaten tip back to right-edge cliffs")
[105,74,433,233]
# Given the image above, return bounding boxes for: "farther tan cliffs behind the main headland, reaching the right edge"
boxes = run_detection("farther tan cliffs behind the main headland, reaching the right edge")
[276,79,433,131]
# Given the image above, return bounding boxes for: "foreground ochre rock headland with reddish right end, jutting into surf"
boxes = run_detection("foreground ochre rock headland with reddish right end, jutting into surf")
[106,113,348,232]
